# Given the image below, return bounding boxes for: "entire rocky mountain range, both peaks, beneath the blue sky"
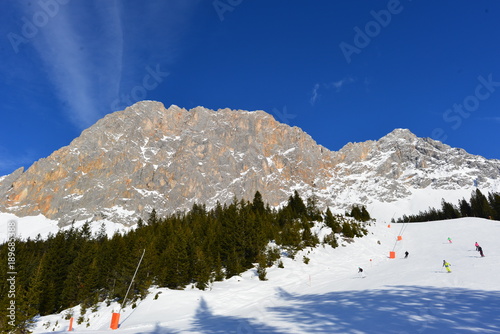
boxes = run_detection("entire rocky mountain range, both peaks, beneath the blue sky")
[0,101,500,225]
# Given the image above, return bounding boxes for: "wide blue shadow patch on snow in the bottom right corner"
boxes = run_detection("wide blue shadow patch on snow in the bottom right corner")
[272,286,500,333]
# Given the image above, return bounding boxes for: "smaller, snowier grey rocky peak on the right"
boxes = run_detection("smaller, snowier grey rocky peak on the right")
[330,129,500,204]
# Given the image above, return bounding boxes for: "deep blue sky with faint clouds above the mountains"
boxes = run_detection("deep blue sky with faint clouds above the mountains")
[0,0,500,175]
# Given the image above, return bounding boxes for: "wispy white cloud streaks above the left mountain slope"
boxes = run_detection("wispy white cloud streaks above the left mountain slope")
[27,1,123,128]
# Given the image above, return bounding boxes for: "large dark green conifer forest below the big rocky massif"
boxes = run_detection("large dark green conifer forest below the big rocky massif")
[0,192,370,333]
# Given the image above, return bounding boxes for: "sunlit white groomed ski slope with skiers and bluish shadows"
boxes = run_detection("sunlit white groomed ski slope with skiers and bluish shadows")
[21,218,500,334]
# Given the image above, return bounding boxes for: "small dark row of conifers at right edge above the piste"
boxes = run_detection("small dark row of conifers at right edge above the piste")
[397,189,500,223]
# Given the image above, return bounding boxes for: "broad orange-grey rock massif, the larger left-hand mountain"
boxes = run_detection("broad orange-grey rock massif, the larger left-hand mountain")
[0,101,332,224]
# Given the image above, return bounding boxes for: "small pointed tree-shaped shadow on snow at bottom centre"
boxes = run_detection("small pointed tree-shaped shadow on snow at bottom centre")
[191,298,284,334]
